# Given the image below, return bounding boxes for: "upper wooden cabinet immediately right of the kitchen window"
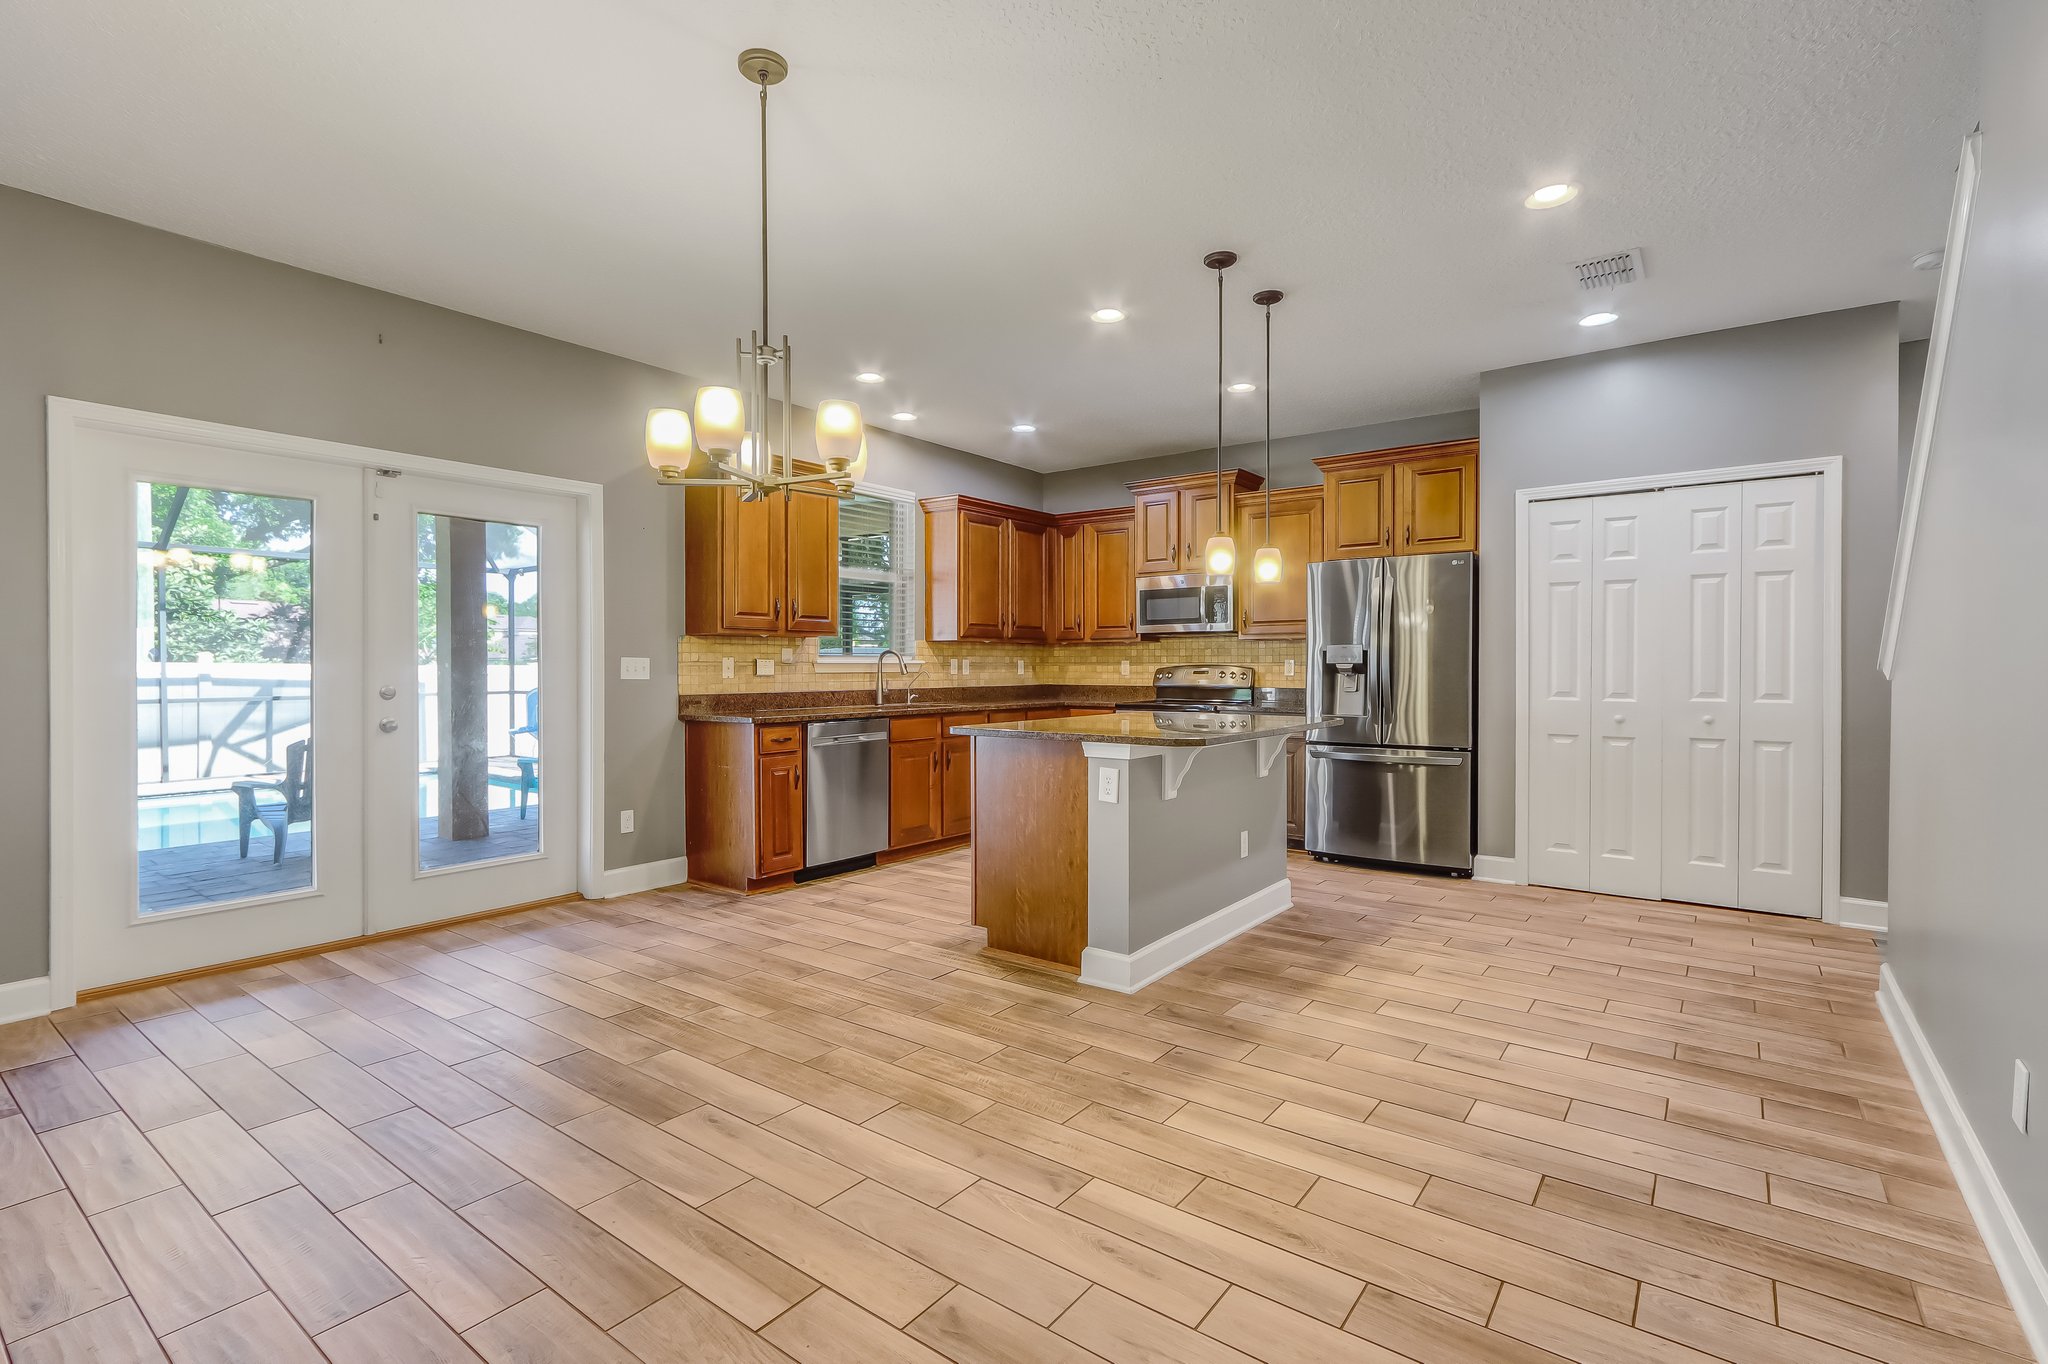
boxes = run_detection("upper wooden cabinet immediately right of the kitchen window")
[920,498,1055,641]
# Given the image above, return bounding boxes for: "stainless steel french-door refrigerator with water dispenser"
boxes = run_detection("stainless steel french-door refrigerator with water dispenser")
[1303,553,1479,877]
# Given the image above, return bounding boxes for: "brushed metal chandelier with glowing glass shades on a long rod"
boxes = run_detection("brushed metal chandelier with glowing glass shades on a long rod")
[647,47,868,502]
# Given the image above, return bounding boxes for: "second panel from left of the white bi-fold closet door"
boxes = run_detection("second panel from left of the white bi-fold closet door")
[1591,494,1667,899]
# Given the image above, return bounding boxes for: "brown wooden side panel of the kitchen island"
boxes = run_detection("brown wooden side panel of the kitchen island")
[973,735,1087,971]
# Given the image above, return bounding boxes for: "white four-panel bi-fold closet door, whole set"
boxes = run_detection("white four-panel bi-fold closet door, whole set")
[1524,475,1825,915]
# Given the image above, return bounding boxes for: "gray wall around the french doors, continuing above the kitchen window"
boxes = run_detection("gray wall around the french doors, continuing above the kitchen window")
[0,186,1038,983]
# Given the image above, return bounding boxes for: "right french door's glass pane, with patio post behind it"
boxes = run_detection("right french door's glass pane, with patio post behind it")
[418,516,541,870]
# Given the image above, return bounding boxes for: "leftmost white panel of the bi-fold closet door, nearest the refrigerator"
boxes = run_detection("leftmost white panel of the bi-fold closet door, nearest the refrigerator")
[1524,498,1593,891]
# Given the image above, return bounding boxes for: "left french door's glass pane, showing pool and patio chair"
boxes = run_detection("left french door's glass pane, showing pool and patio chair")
[135,483,313,915]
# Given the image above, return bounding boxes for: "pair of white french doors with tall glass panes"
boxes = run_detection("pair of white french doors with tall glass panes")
[51,413,582,989]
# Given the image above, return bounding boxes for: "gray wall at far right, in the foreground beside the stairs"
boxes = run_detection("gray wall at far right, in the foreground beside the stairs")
[1888,0,2048,1277]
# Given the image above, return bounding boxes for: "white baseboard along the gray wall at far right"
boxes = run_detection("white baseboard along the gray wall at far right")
[1878,965,2048,1360]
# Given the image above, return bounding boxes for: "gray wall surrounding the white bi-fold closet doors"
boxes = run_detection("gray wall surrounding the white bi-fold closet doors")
[1479,303,1901,899]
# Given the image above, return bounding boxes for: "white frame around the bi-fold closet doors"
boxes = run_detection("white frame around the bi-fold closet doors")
[1515,455,1843,924]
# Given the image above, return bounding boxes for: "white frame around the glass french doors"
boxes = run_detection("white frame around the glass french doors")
[47,395,604,1012]
